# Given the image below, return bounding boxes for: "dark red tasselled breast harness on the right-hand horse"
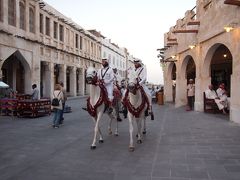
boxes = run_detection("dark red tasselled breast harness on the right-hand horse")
[123,86,149,118]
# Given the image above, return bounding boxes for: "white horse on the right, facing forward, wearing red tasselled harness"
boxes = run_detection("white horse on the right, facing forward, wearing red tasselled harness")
[123,72,148,151]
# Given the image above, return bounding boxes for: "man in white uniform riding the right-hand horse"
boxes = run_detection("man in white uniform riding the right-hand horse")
[133,59,152,114]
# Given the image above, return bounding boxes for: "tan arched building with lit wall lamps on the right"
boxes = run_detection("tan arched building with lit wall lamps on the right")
[162,0,240,123]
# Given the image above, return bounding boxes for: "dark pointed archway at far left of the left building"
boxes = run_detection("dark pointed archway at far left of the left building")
[1,50,31,94]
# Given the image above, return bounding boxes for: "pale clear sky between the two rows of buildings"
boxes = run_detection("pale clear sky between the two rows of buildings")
[44,0,196,84]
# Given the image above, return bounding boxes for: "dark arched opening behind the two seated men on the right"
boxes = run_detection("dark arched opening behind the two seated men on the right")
[210,44,232,93]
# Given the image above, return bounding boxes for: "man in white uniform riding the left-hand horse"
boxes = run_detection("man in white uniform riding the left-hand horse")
[97,58,114,113]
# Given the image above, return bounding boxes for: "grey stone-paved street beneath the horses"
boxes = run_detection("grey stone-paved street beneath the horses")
[0,99,240,180]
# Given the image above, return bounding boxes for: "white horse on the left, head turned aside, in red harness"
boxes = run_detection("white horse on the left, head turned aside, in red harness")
[86,67,118,149]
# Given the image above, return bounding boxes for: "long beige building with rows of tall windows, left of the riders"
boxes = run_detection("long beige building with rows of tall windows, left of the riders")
[0,0,101,97]
